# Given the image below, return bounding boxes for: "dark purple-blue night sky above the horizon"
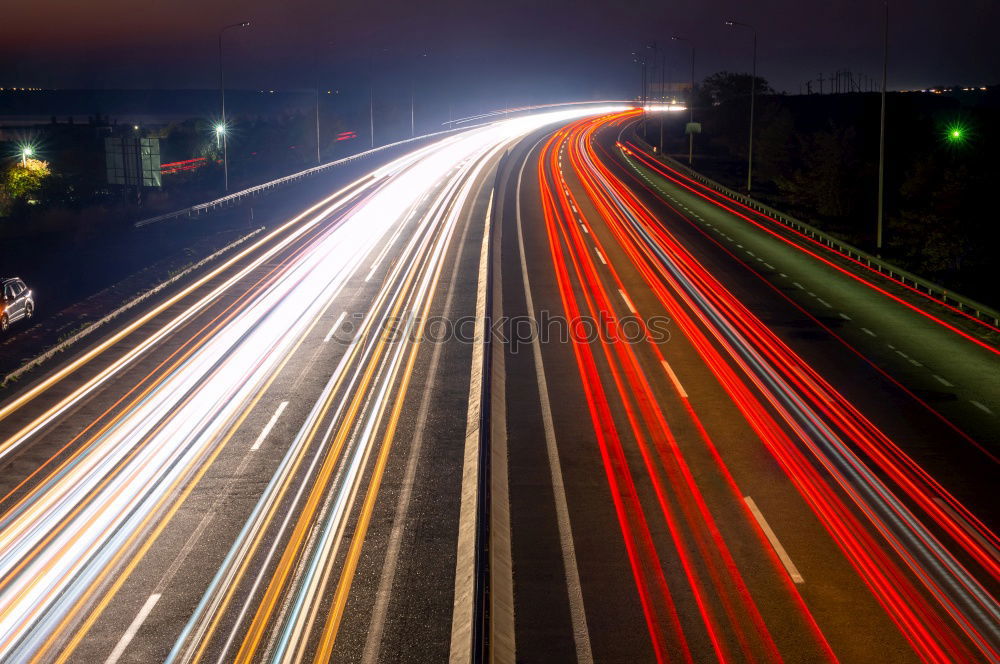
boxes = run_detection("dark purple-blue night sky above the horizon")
[0,0,1000,98]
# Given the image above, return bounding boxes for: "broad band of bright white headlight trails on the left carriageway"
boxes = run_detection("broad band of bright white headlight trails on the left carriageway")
[0,107,621,660]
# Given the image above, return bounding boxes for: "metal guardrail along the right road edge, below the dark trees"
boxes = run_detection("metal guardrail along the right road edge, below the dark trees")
[630,131,1000,327]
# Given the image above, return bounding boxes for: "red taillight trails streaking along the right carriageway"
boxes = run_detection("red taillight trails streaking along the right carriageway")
[538,113,1000,662]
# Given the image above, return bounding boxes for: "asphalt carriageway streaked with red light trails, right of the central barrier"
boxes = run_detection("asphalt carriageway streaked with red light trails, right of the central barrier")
[503,113,1000,662]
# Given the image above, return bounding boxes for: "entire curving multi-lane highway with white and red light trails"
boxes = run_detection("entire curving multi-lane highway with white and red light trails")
[0,105,1000,664]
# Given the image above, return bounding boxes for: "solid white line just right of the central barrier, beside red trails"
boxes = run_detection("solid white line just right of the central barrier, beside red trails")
[515,141,592,664]
